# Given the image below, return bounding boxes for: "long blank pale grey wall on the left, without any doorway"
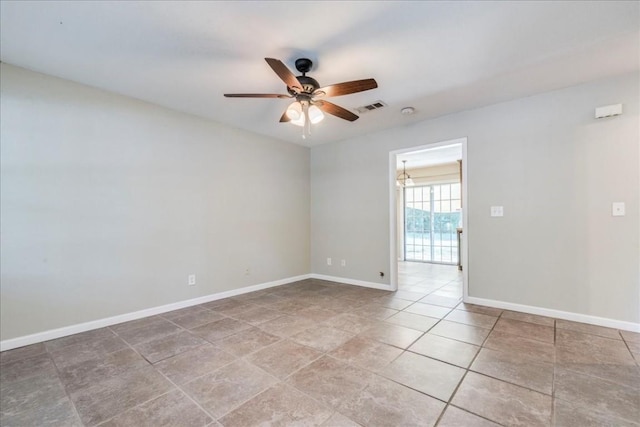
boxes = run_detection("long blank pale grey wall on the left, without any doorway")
[0,64,310,340]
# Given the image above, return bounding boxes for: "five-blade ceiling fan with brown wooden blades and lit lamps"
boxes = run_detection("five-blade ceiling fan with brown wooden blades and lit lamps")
[224,58,378,138]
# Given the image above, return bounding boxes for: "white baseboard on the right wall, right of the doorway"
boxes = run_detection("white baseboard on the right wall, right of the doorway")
[464,297,640,332]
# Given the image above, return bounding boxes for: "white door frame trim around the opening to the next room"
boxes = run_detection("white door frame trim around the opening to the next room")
[389,137,469,301]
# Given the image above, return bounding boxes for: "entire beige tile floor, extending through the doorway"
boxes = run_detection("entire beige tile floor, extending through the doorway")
[0,263,640,427]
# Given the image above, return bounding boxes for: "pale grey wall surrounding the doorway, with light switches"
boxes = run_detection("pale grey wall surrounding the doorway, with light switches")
[311,73,640,323]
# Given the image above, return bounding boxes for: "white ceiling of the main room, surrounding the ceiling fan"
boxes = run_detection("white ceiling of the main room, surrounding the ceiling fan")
[0,0,640,146]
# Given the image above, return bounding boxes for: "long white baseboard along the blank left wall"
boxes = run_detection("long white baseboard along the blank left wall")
[0,274,311,351]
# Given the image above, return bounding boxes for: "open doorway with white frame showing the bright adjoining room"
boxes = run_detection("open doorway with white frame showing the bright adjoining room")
[389,138,468,297]
